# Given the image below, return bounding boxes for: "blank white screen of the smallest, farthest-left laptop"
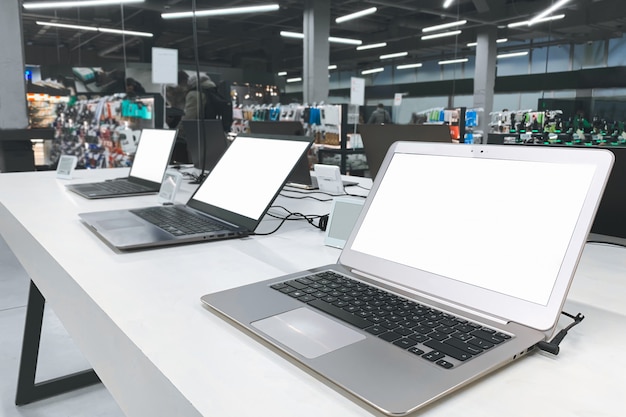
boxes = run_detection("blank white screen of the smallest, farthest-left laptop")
[130,129,176,183]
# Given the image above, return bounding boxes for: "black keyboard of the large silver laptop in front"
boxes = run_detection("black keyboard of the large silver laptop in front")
[272,271,511,369]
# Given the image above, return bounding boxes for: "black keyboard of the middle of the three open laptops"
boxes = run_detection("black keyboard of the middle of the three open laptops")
[131,206,226,236]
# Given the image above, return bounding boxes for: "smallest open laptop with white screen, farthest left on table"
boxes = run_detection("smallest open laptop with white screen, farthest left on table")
[66,129,176,199]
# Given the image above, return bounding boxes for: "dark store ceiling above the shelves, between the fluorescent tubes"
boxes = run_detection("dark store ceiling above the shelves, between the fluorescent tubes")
[22,0,626,73]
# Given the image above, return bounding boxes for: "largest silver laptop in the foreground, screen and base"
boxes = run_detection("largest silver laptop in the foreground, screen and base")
[201,142,613,416]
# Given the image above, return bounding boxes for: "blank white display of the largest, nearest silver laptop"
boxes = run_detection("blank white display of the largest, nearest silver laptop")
[351,154,595,305]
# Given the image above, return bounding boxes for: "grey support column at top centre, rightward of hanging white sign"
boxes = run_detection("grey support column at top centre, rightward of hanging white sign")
[302,0,330,103]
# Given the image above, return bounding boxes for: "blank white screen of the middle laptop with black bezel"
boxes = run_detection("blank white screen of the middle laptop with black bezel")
[193,136,310,219]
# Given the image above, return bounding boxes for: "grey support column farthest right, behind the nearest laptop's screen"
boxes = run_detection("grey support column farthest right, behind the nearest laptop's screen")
[474,28,497,143]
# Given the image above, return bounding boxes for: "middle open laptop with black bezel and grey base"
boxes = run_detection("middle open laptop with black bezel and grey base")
[79,135,312,251]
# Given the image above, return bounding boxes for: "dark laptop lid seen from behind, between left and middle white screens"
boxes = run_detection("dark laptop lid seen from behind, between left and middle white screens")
[181,119,228,171]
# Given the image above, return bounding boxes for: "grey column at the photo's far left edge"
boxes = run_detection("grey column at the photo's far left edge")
[0,0,28,130]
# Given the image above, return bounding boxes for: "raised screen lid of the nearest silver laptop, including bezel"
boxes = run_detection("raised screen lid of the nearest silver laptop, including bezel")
[340,142,613,331]
